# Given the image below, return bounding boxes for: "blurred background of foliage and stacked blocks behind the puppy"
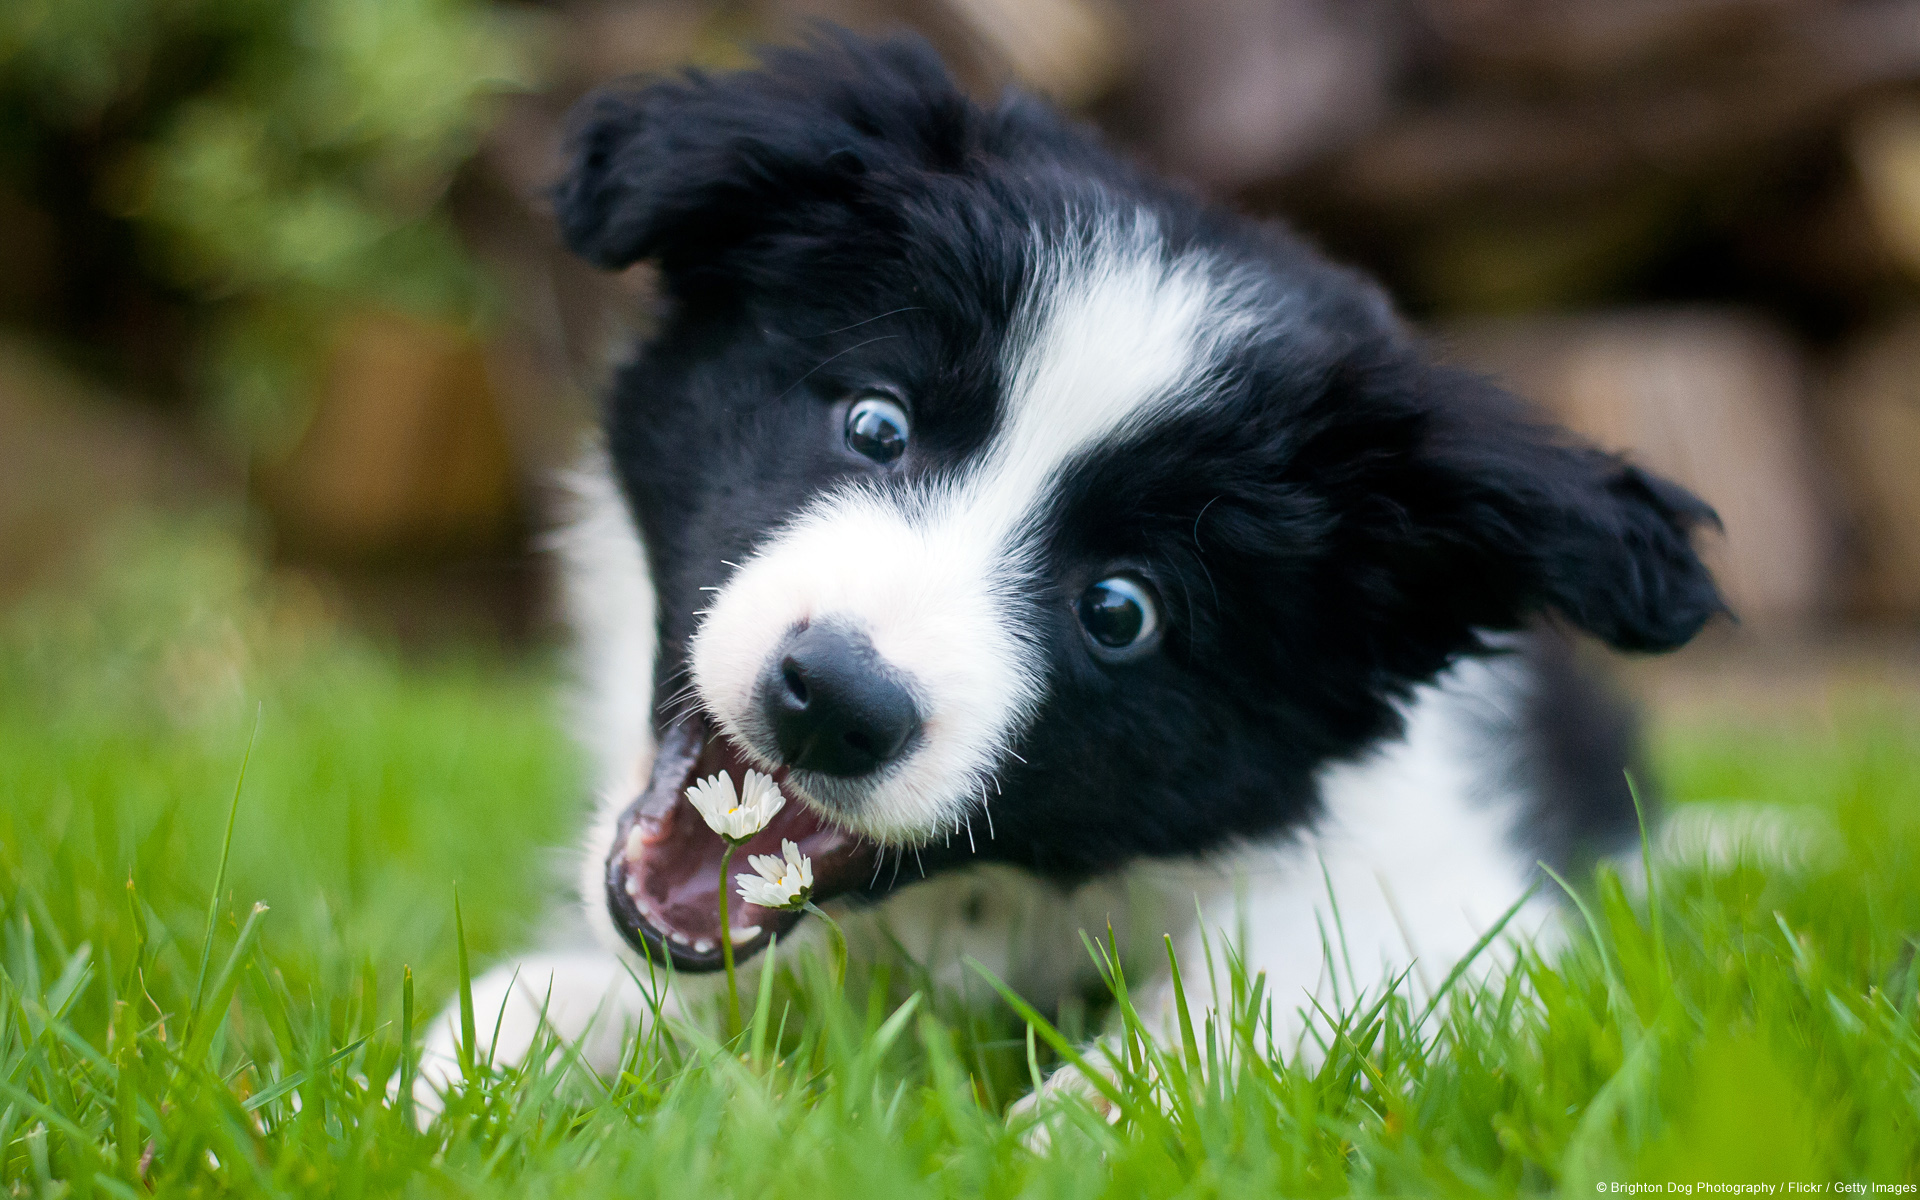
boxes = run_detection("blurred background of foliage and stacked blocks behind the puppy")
[0,0,1920,707]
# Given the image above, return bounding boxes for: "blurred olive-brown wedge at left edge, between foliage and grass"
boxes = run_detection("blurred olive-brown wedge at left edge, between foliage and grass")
[0,340,234,599]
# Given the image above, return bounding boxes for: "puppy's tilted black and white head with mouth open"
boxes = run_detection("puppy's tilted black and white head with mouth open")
[557,38,1720,970]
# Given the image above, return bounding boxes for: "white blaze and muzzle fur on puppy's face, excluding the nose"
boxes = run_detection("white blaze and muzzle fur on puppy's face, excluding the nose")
[691,217,1252,841]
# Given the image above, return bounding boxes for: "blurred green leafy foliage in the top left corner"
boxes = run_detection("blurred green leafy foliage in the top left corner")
[0,0,541,447]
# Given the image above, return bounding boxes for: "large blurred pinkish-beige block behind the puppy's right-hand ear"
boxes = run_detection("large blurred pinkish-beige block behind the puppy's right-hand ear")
[1446,309,1836,630]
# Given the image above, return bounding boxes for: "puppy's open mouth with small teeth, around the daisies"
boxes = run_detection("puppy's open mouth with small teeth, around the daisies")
[607,716,876,972]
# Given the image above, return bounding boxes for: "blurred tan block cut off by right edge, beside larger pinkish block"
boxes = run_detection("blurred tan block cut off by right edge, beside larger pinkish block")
[1818,313,1920,620]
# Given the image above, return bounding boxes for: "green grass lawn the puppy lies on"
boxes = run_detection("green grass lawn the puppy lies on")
[0,510,1920,1200]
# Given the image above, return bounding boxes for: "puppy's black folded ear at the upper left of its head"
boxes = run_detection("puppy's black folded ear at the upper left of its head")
[553,33,977,275]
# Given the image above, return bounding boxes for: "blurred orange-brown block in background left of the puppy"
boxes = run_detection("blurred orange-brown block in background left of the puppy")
[263,313,518,561]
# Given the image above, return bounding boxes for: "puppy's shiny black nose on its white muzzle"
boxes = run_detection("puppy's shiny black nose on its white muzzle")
[760,624,920,776]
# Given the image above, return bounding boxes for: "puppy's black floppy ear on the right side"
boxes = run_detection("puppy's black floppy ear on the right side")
[1394,371,1726,651]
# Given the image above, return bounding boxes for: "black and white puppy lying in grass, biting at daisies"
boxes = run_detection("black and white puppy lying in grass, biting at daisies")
[420,25,1722,1079]
